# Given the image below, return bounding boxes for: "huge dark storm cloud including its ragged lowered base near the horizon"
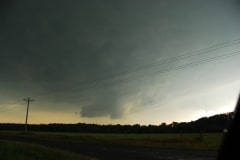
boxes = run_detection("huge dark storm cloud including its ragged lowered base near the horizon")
[0,0,240,118]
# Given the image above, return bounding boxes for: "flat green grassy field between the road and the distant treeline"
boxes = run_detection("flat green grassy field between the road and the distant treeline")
[0,132,223,151]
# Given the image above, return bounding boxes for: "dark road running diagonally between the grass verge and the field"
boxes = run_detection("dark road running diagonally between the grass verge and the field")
[0,135,217,160]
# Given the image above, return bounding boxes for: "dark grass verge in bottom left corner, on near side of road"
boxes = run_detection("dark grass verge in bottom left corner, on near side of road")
[0,140,94,160]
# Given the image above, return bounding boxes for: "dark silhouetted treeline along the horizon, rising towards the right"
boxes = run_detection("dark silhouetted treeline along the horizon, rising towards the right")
[0,112,233,133]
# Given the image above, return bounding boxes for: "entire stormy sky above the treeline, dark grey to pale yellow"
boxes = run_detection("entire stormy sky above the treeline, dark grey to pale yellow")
[0,0,240,124]
